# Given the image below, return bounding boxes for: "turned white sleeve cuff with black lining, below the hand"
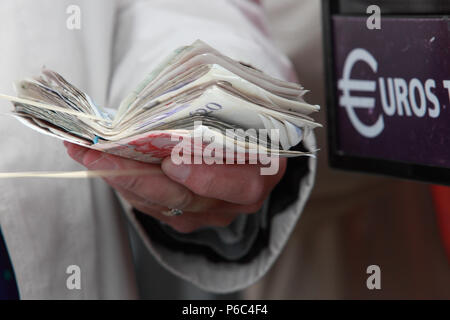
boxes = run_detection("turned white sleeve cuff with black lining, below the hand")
[119,135,316,293]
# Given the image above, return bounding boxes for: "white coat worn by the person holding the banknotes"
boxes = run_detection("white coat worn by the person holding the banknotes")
[0,0,315,299]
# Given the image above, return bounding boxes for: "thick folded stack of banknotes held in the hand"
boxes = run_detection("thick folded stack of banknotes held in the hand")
[5,40,320,163]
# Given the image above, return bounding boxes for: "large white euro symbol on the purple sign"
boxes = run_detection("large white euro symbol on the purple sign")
[338,48,384,138]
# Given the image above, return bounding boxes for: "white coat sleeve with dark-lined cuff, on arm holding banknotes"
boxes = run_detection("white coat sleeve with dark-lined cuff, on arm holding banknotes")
[109,0,316,292]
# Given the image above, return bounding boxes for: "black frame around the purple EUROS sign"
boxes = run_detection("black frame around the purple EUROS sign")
[322,0,450,185]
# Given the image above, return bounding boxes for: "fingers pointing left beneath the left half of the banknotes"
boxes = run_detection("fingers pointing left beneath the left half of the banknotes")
[65,144,262,215]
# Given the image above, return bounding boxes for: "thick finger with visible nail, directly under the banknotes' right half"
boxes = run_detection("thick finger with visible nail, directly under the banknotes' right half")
[161,158,286,205]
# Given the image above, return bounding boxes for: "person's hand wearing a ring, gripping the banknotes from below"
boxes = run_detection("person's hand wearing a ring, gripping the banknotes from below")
[64,142,286,233]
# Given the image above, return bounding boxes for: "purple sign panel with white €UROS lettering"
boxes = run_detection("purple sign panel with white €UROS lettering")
[333,16,450,168]
